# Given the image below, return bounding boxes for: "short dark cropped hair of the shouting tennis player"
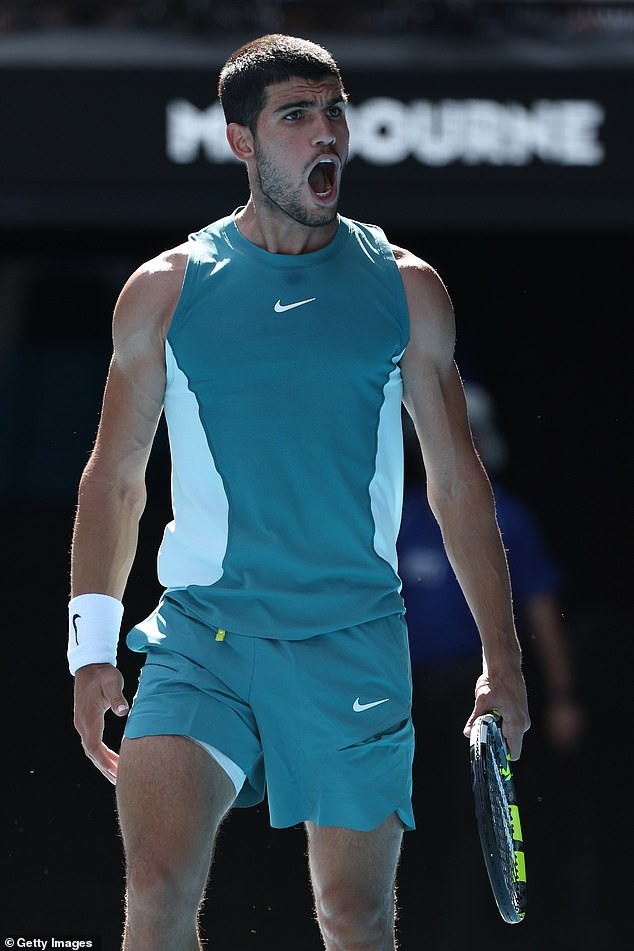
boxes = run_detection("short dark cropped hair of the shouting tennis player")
[218,33,345,131]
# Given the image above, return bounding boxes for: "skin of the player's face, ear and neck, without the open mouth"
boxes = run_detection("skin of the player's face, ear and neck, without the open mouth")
[227,78,349,254]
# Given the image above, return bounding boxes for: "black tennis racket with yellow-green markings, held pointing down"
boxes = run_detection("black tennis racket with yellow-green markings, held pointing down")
[469,711,526,924]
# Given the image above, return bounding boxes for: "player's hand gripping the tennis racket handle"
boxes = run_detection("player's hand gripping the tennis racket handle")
[464,669,531,760]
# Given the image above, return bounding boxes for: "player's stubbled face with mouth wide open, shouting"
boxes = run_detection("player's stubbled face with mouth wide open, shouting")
[253,77,349,228]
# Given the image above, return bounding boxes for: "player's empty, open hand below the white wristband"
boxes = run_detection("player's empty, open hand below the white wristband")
[74,664,129,785]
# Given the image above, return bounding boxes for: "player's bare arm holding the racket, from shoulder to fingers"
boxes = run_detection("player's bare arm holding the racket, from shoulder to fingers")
[395,249,530,759]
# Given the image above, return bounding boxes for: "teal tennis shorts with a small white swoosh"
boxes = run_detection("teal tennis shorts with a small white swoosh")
[125,598,414,831]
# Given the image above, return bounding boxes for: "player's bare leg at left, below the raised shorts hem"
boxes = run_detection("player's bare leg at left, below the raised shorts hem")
[117,736,235,951]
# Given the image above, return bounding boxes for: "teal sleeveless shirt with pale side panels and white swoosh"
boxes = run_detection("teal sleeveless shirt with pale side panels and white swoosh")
[158,215,409,639]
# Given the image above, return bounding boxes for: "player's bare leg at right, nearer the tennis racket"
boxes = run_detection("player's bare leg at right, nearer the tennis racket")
[306,815,403,951]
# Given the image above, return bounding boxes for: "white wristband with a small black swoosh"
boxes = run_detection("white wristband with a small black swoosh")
[68,594,123,677]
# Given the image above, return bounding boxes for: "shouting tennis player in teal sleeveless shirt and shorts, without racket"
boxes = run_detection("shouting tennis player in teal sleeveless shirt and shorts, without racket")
[68,35,529,951]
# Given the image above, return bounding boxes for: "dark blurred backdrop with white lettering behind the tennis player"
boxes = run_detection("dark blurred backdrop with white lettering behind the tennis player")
[0,0,634,951]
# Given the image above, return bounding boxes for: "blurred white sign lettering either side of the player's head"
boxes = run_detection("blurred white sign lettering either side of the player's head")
[167,97,605,167]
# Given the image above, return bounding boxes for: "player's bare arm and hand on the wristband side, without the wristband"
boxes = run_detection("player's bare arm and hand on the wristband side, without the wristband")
[71,247,186,782]
